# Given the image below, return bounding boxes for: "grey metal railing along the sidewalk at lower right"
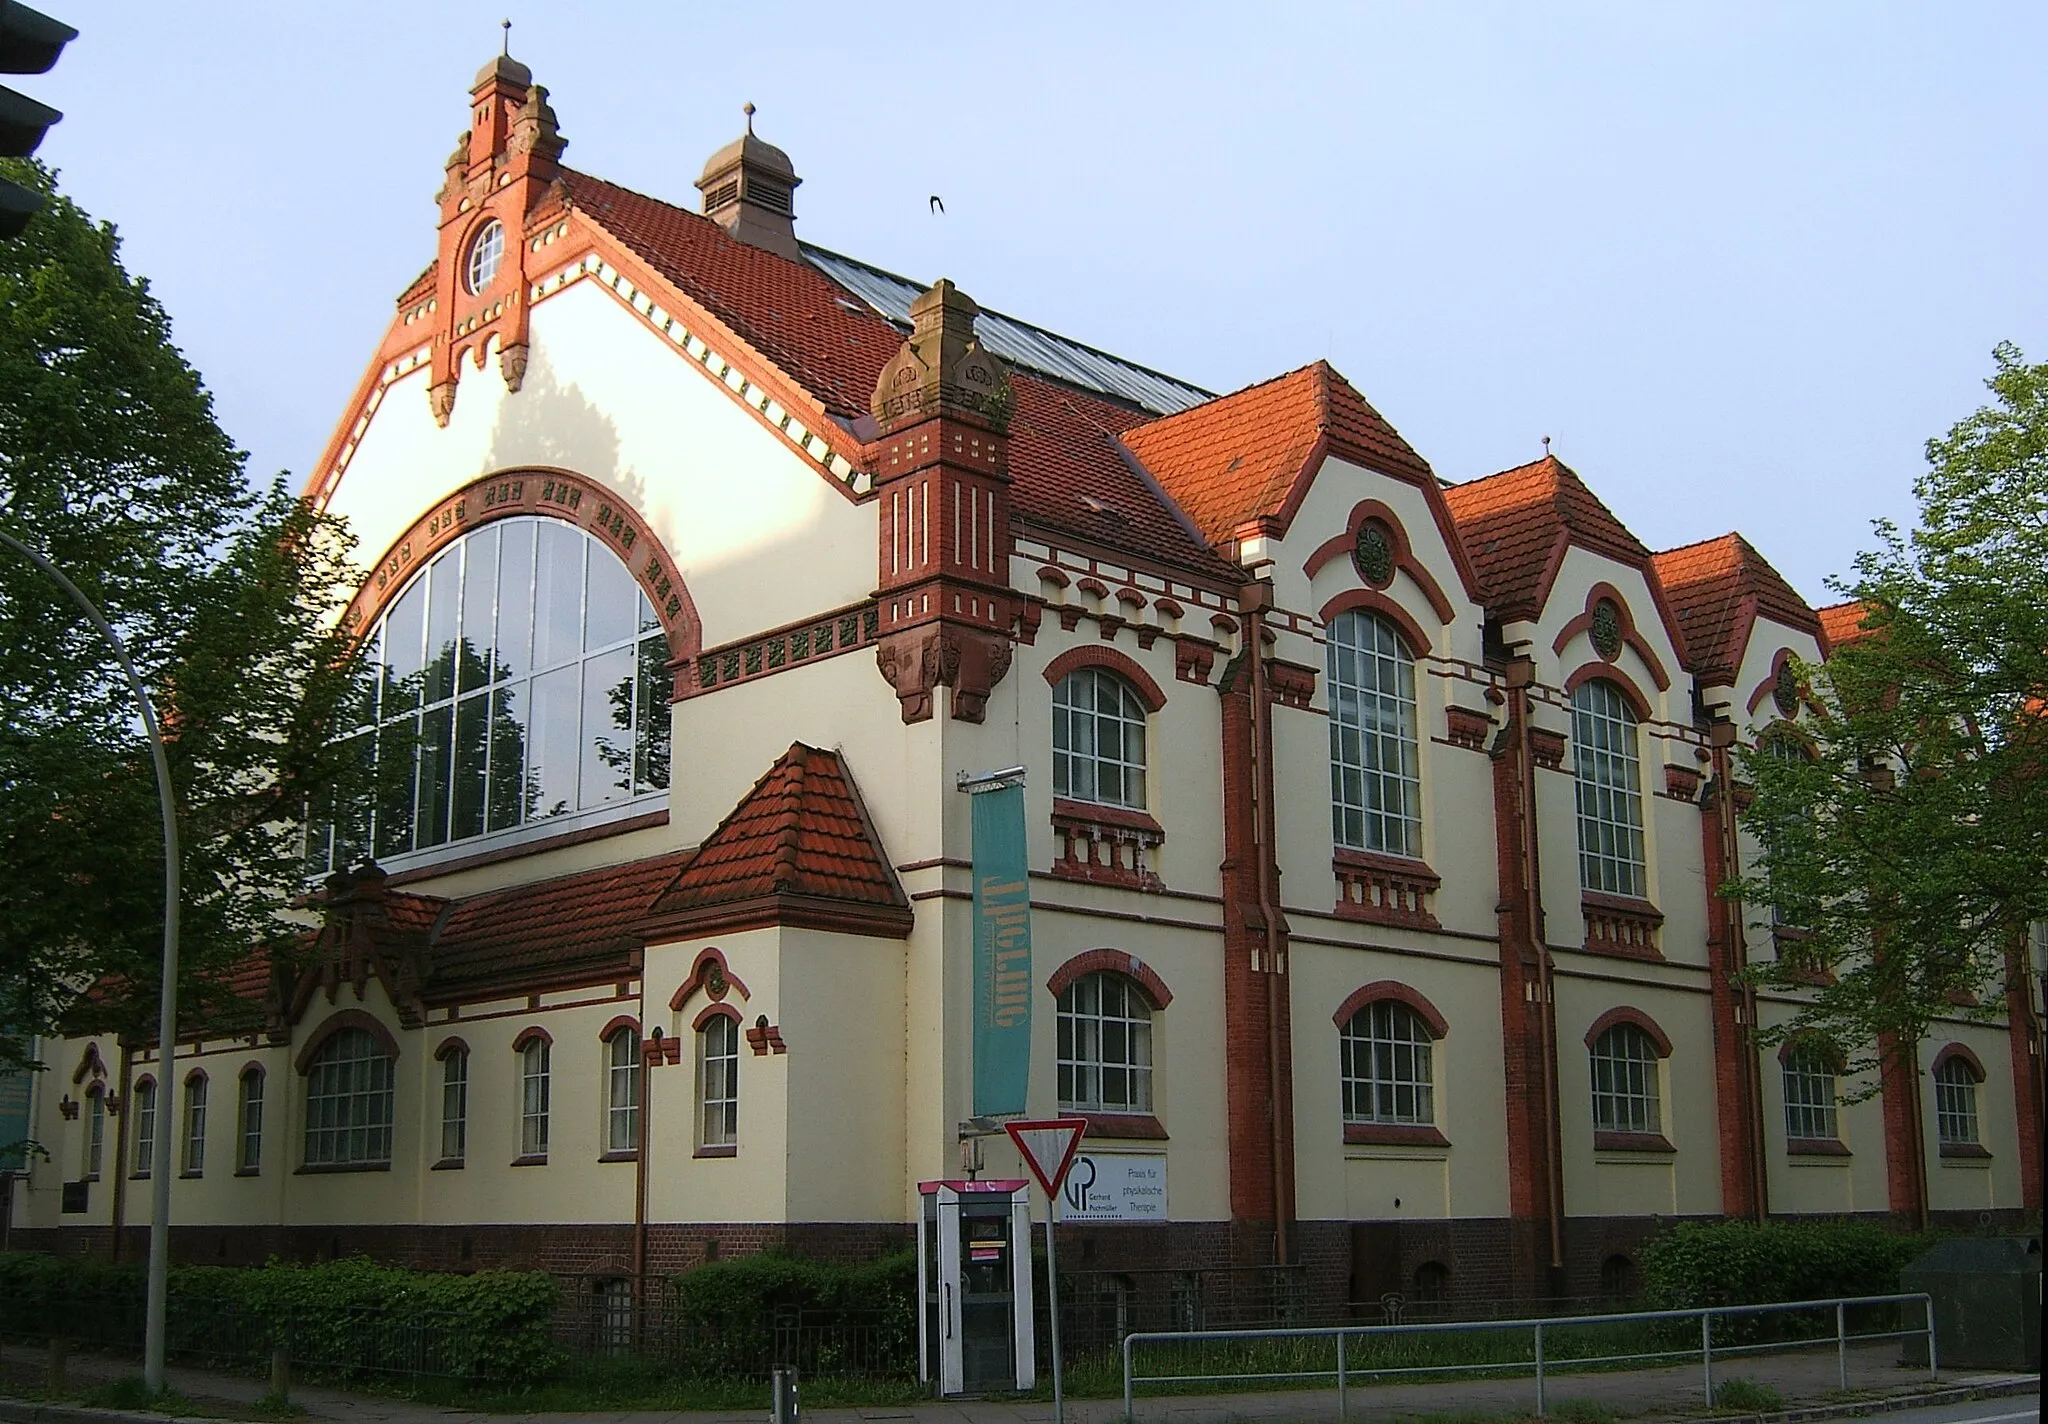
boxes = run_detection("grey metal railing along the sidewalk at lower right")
[1124,1293,1942,1422]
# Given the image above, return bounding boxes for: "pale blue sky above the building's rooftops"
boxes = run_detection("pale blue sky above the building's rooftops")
[28,0,2048,602]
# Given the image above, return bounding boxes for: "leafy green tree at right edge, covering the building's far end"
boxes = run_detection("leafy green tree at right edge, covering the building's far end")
[1731,344,2048,1067]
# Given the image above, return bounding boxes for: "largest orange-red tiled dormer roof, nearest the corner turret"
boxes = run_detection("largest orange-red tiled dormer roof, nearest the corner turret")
[1124,361,1436,543]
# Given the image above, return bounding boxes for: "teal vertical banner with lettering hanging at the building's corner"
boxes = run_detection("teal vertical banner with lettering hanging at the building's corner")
[969,787,1032,1117]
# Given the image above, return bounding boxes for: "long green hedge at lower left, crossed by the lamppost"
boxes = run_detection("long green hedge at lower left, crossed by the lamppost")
[0,1252,561,1385]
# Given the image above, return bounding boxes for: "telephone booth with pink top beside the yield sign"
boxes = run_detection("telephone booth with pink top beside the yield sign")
[918,1180,1038,1395]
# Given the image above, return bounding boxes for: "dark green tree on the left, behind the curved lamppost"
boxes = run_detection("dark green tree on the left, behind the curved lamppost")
[0,162,362,1067]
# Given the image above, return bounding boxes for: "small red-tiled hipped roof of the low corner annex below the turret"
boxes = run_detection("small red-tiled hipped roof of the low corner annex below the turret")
[653,742,911,938]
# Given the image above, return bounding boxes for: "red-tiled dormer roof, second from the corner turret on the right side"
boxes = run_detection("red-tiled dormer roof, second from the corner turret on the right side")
[1444,455,1646,618]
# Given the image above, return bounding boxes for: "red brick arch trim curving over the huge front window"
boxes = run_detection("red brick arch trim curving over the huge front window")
[342,467,702,658]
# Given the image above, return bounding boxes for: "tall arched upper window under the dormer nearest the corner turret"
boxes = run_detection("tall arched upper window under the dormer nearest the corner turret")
[1327,613,1421,856]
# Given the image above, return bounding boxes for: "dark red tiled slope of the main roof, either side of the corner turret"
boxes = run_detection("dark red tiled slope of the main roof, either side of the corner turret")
[563,170,1239,580]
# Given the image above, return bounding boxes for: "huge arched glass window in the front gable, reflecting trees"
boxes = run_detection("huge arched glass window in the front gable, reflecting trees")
[313,516,670,867]
